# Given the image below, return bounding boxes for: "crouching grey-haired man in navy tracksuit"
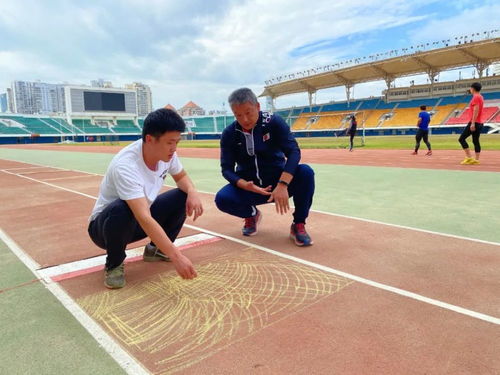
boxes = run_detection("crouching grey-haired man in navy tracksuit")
[215,88,314,246]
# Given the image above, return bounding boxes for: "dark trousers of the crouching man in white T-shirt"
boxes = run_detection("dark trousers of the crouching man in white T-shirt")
[88,189,187,269]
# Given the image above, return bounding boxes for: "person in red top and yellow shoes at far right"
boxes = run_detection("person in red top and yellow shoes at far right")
[458,82,485,165]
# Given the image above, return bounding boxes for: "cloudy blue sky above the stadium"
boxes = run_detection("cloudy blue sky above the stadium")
[0,0,500,110]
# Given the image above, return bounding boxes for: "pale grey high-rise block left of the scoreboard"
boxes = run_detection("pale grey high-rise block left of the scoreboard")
[12,81,66,114]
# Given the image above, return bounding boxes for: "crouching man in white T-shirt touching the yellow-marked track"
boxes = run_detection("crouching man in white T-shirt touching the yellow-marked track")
[88,108,203,289]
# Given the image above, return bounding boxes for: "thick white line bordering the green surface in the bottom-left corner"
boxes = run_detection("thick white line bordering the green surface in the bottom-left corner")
[0,229,150,375]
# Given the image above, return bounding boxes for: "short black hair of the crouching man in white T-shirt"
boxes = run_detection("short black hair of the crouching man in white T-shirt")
[142,108,186,141]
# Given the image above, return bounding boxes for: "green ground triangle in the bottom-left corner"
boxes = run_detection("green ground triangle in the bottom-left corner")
[0,241,125,375]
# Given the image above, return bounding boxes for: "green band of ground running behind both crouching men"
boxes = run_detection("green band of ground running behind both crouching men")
[0,148,500,243]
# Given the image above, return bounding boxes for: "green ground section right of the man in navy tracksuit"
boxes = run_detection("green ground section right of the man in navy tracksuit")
[313,164,500,243]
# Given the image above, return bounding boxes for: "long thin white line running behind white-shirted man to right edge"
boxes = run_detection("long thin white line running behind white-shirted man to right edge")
[1,164,500,325]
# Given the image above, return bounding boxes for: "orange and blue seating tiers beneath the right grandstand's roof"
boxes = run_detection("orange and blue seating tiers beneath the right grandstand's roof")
[276,76,500,134]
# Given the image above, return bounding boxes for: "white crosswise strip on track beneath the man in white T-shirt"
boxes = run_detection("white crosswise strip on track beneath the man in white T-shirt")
[38,233,215,282]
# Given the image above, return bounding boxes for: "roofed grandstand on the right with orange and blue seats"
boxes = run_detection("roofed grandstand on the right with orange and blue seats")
[260,30,500,136]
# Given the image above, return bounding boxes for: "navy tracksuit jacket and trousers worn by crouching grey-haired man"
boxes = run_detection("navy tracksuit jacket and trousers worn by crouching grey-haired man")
[215,112,314,223]
